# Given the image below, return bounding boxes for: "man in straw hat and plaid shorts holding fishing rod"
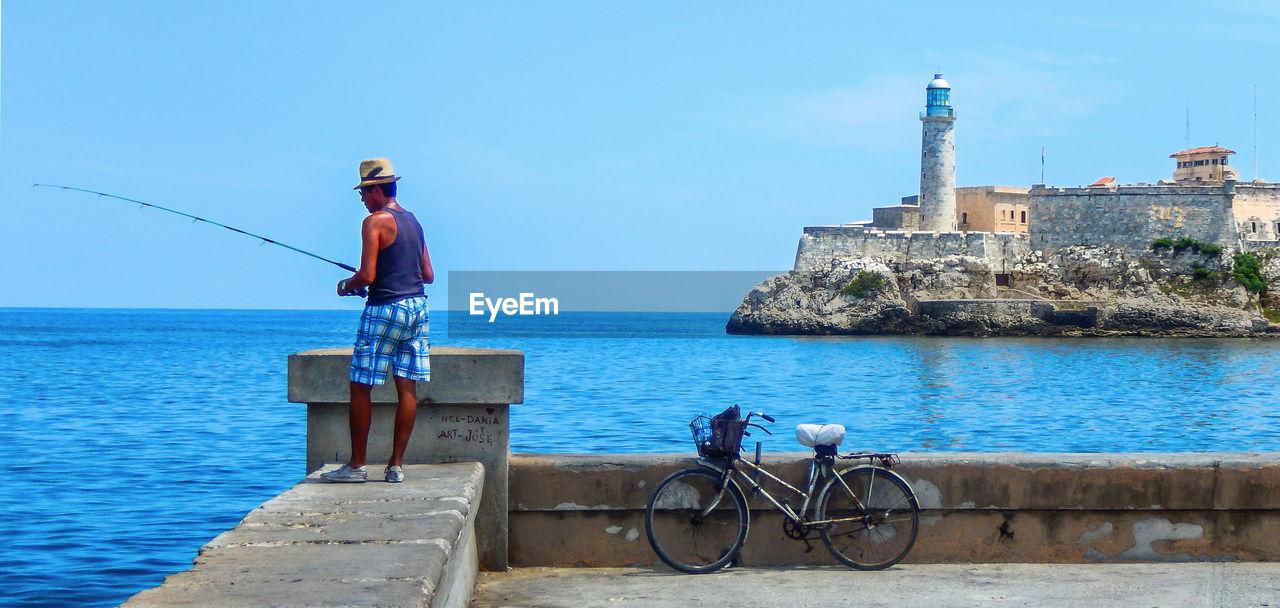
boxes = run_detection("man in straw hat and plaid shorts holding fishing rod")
[320,159,435,483]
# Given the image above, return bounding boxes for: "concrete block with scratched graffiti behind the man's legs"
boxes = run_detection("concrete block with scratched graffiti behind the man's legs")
[289,346,525,570]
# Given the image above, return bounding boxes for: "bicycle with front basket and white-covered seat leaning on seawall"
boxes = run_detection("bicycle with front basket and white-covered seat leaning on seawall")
[644,406,920,573]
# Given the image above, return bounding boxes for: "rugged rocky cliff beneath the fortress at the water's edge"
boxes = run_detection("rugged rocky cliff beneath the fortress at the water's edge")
[726,246,1280,337]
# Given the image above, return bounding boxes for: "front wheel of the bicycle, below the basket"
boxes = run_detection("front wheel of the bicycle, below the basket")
[644,468,750,575]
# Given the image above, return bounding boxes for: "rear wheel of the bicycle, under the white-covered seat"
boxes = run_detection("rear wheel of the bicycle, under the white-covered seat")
[817,466,920,570]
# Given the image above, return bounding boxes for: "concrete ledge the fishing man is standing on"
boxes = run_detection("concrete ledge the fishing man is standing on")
[123,462,484,608]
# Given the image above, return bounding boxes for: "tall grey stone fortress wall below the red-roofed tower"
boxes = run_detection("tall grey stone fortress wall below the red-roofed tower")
[1029,183,1236,253]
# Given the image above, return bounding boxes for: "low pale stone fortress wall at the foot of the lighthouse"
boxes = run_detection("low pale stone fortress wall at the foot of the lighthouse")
[794,225,1029,271]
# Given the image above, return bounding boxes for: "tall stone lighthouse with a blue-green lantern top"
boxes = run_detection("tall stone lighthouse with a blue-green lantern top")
[919,74,956,232]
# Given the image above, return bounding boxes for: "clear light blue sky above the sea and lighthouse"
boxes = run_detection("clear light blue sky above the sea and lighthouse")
[0,0,1280,308]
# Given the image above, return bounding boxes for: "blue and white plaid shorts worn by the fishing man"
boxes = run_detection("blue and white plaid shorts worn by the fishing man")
[351,297,431,384]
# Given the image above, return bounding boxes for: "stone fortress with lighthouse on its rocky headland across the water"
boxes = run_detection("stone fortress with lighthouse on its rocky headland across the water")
[727,74,1280,335]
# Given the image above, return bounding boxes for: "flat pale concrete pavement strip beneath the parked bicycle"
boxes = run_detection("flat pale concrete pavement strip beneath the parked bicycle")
[471,560,1280,608]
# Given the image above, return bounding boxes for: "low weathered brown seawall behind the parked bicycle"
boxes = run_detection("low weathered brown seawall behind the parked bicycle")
[509,453,1280,567]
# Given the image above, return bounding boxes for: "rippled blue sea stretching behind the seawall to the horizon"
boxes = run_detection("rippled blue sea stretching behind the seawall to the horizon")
[0,308,1280,605]
